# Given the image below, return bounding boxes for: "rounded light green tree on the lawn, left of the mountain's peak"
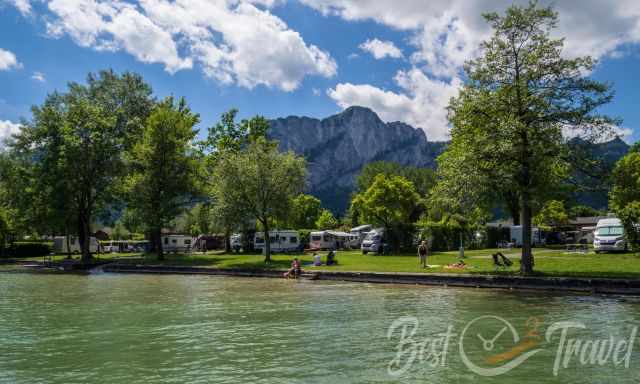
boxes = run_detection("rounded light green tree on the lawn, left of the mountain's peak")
[213,137,306,262]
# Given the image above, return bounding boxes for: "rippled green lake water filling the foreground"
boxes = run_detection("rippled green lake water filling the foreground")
[0,274,640,384]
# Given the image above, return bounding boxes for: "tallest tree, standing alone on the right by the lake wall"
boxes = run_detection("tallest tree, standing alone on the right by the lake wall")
[439,2,614,274]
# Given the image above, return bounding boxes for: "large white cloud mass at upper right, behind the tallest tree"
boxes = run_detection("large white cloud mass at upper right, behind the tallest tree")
[301,0,640,139]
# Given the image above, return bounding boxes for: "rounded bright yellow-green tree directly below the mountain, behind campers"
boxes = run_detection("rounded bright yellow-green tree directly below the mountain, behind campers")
[351,174,422,251]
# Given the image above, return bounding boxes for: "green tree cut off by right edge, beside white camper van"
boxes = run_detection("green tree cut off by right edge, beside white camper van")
[609,150,640,251]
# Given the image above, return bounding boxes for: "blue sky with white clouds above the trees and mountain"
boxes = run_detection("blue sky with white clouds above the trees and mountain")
[0,0,640,143]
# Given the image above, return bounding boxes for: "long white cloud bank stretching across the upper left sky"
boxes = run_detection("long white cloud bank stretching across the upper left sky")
[40,0,337,91]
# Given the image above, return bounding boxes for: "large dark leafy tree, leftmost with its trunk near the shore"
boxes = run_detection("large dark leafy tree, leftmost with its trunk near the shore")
[11,71,155,262]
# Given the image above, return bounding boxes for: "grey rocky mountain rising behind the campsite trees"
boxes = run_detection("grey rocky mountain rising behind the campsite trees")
[269,107,446,213]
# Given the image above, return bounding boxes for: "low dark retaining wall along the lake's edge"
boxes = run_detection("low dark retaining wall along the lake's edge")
[101,264,640,295]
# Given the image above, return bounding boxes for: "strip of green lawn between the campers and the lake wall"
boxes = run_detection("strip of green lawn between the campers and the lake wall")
[26,248,640,278]
